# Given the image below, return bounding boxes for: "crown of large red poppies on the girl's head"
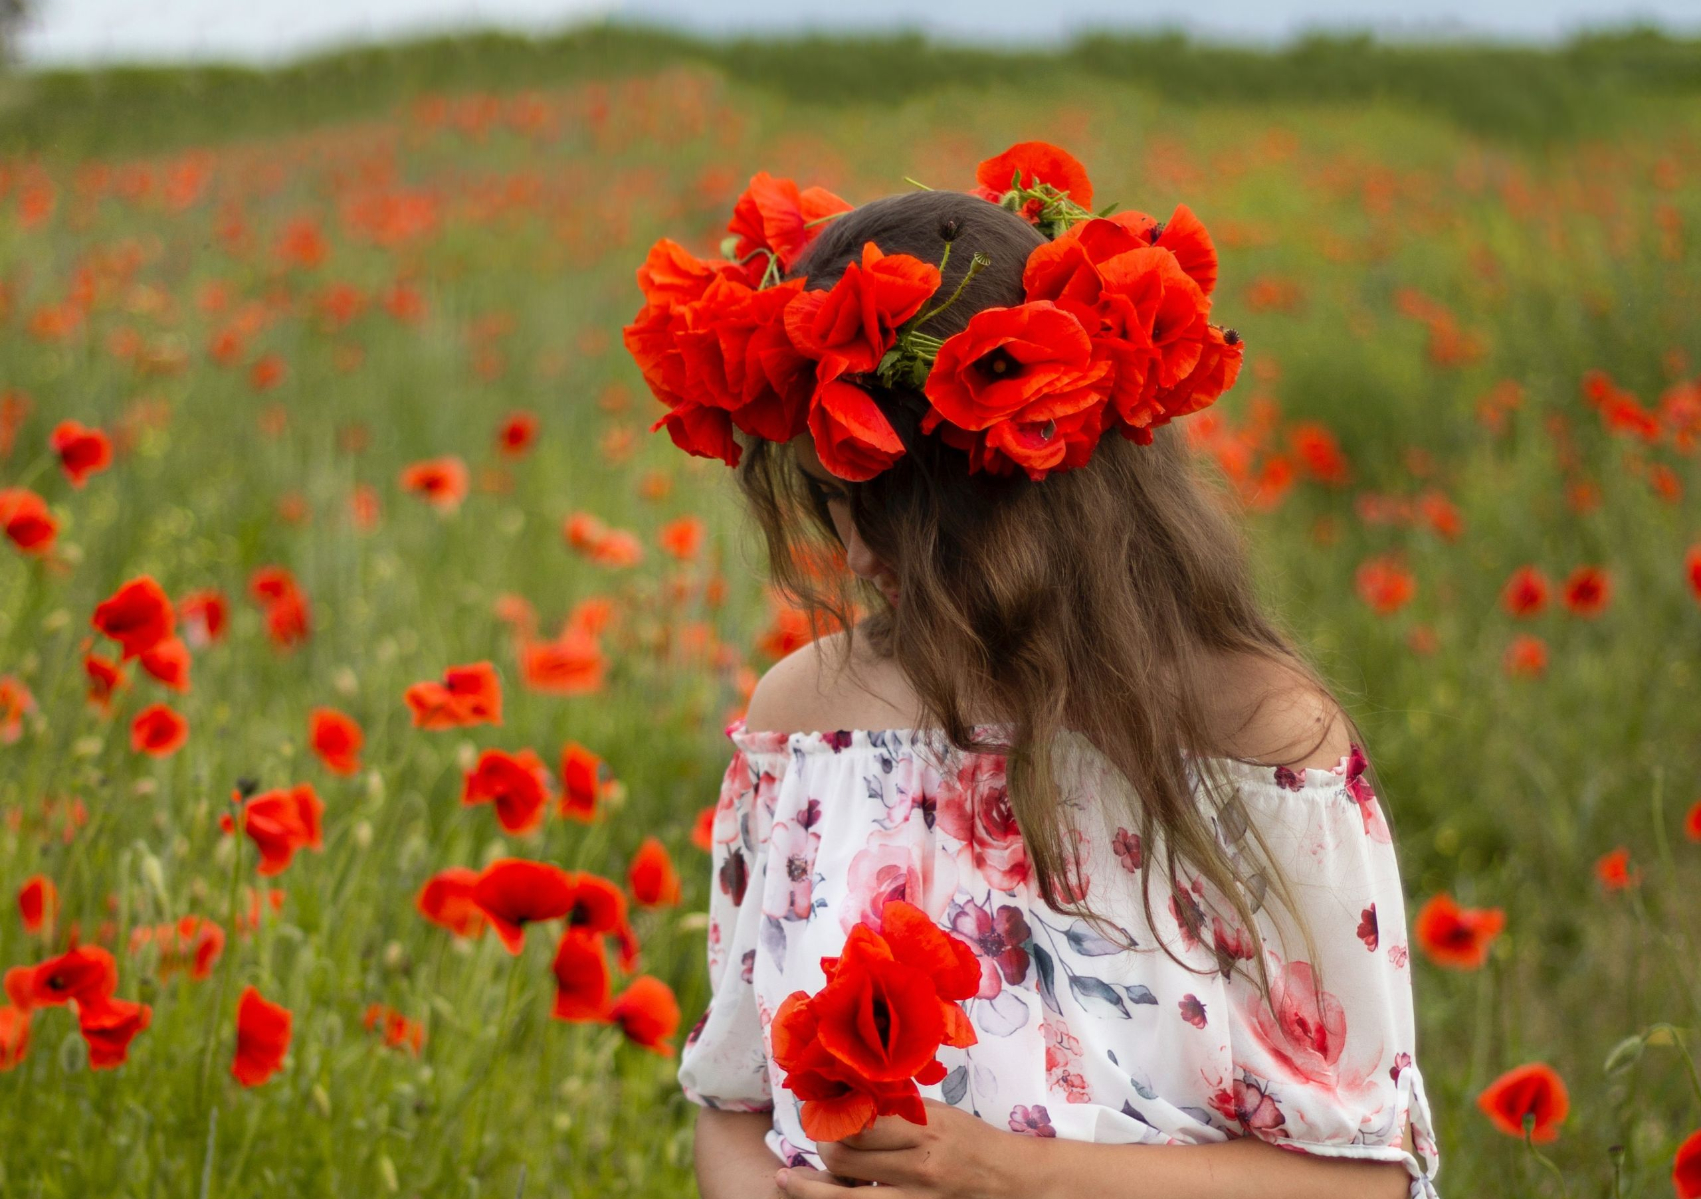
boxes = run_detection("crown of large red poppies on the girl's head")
[624,141,1243,481]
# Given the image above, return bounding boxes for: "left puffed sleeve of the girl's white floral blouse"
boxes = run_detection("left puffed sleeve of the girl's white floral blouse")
[679,747,786,1112]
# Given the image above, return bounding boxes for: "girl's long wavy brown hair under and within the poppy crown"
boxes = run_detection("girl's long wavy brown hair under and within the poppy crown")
[738,192,1351,997]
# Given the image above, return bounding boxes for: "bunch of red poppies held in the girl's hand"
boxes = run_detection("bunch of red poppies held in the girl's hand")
[771,900,980,1141]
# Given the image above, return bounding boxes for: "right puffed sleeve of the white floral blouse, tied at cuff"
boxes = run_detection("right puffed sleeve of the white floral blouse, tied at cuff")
[1220,747,1439,1199]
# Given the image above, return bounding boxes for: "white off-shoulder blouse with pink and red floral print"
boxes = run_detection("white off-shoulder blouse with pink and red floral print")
[679,718,1439,1199]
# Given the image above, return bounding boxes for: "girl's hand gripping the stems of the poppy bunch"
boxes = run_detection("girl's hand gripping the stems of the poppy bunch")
[776,1099,1015,1199]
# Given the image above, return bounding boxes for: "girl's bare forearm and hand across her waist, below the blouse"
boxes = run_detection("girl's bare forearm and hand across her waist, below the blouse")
[789,1100,1410,1199]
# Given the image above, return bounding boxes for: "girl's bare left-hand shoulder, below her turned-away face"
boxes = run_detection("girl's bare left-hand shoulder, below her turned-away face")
[745,631,915,733]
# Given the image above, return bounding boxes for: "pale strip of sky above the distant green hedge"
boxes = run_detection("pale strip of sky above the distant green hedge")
[20,0,1701,66]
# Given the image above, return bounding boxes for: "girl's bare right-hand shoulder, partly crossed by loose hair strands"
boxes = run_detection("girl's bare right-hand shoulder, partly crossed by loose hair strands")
[1213,658,1352,770]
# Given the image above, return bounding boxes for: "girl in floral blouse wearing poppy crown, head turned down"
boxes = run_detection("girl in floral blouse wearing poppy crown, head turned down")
[628,143,1437,1199]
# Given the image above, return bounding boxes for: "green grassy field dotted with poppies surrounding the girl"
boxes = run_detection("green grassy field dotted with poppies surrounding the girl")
[0,28,1701,1199]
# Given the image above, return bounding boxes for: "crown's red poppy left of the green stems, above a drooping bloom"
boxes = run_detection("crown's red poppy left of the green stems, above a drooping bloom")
[786,242,939,378]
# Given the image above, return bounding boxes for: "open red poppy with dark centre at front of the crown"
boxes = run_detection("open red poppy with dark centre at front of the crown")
[920,299,1111,480]
